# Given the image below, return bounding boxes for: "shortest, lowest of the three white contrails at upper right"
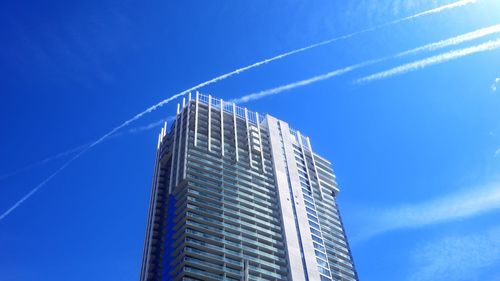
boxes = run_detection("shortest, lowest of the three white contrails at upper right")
[355,39,500,83]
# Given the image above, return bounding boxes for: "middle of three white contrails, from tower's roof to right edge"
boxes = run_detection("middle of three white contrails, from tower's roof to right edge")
[231,24,500,103]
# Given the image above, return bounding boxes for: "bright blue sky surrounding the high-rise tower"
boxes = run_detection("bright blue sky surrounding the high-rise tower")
[0,0,500,281]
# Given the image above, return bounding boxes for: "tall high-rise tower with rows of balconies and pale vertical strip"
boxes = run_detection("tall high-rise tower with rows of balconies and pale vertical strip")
[140,93,358,281]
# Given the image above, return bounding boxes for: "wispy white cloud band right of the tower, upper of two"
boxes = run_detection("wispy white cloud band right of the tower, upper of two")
[358,182,500,239]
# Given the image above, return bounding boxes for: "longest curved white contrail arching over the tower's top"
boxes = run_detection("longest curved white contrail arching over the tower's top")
[0,0,477,221]
